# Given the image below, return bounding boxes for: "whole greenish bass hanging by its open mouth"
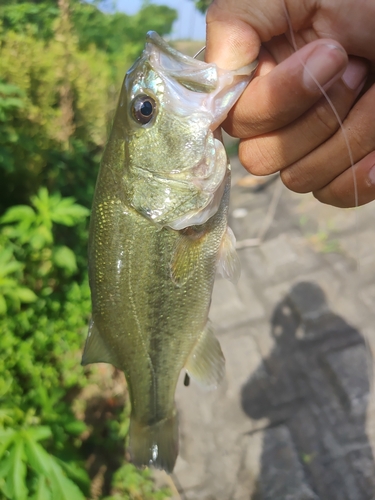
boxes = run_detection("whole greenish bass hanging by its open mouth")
[82,32,256,473]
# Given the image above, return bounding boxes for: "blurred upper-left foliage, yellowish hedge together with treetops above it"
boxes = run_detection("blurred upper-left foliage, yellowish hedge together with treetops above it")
[0,1,176,212]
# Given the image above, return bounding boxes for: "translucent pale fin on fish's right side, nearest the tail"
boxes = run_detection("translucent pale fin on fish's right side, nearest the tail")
[185,323,225,388]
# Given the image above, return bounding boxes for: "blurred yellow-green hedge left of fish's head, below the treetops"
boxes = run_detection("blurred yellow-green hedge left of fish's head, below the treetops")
[0,23,111,209]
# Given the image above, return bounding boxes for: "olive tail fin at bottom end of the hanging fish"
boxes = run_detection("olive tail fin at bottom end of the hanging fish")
[130,413,178,473]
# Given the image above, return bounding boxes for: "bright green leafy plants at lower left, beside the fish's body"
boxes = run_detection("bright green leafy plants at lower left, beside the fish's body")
[0,188,90,500]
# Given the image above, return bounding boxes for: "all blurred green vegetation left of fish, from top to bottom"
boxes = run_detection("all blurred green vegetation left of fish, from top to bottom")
[0,0,212,500]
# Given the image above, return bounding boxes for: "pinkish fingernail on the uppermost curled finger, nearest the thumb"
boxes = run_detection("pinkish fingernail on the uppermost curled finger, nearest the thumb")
[303,44,347,91]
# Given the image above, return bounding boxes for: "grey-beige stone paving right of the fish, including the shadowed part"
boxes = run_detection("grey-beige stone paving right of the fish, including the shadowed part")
[172,157,375,500]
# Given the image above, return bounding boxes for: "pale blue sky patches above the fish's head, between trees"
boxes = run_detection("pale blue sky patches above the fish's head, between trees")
[116,0,206,40]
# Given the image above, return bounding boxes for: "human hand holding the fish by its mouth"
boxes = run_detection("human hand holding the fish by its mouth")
[206,0,375,207]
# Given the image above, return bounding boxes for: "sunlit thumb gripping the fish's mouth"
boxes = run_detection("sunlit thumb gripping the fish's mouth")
[205,0,261,70]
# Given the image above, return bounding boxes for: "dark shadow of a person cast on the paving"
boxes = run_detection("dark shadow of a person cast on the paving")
[241,282,375,500]
